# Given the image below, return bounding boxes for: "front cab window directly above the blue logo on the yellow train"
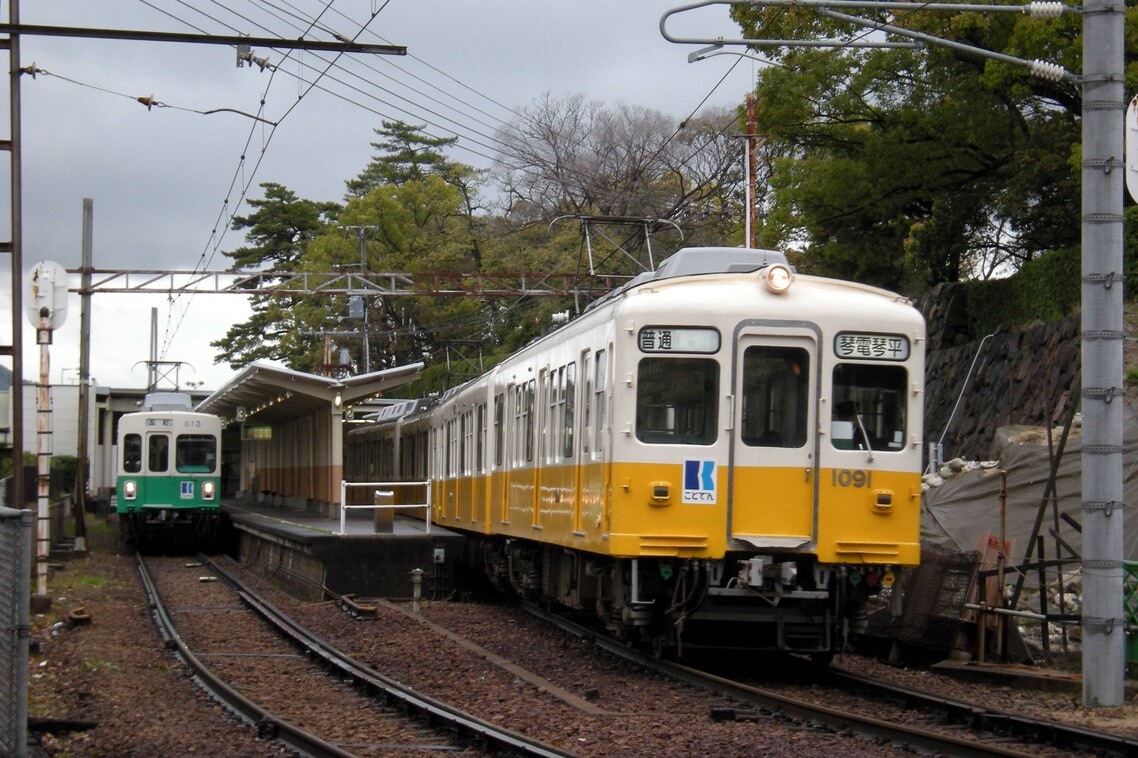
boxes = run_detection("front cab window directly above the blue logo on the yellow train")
[636,357,719,445]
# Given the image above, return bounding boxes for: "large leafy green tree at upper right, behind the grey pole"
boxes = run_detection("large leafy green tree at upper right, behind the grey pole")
[732,6,1081,291]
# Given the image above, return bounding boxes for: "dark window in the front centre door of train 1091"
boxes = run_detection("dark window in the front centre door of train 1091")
[740,346,810,447]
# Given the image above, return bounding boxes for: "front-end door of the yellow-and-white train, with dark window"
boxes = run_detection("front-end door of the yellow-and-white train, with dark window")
[728,334,818,550]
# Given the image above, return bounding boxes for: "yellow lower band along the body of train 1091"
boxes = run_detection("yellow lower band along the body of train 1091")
[434,463,921,566]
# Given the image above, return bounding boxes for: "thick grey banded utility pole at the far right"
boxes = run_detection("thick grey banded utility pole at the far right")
[1082,0,1125,707]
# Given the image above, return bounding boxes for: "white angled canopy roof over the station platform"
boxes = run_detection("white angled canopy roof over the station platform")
[196,362,423,425]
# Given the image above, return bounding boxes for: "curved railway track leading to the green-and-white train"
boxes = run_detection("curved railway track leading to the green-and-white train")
[137,548,567,757]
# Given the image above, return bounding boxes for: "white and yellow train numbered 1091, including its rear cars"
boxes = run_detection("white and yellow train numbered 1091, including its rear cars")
[345,248,925,659]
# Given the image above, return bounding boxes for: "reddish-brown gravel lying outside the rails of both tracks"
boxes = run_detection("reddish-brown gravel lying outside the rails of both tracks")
[22,518,1138,758]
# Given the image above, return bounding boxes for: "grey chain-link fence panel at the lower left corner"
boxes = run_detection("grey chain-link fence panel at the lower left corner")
[0,508,33,758]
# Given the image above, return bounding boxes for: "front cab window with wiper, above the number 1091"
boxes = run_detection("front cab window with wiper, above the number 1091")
[830,363,908,451]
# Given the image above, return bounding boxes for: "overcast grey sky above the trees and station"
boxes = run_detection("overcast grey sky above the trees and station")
[0,0,754,389]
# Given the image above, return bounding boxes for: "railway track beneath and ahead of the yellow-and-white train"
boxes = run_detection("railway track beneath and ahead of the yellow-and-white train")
[526,604,1138,758]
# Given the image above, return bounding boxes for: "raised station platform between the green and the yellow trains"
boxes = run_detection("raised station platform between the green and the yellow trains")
[222,500,465,601]
